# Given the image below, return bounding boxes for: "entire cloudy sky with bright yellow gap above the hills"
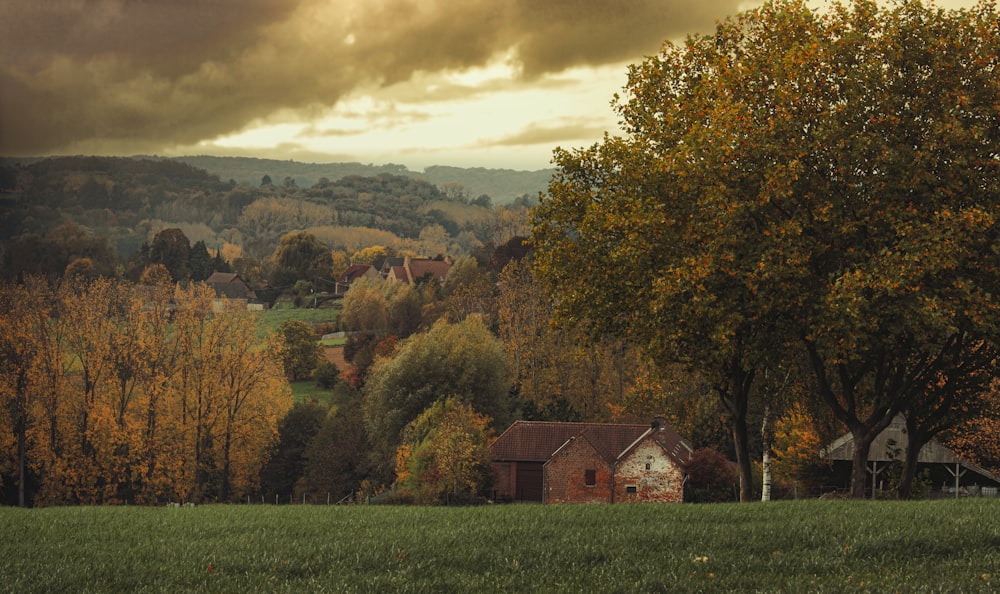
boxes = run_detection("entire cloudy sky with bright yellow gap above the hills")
[0,0,984,171]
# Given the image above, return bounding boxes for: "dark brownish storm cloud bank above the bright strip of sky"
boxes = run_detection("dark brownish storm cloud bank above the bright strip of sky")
[0,0,737,155]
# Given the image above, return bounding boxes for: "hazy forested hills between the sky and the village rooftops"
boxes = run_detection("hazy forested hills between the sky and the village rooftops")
[0,156,545,277]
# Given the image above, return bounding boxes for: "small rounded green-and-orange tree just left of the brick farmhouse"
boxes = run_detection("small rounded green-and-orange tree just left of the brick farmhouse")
[396,397,493,504]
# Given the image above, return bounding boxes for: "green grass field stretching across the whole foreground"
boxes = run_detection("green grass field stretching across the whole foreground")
[0,499,1000,593]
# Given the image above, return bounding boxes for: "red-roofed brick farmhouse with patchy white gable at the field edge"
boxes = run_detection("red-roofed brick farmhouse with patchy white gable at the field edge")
[490,418,693,503]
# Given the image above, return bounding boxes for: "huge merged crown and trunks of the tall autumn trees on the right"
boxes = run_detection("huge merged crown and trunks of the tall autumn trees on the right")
[535,0,1000,500]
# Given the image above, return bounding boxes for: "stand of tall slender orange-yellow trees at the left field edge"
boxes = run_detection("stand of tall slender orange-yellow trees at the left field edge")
[0,279,292,505]
